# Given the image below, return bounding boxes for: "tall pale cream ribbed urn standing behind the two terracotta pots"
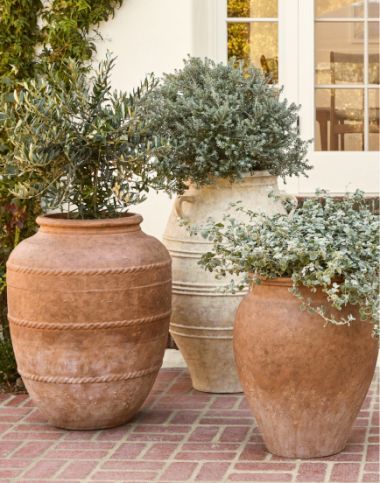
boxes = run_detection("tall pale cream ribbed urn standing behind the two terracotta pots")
[164,172,283,393]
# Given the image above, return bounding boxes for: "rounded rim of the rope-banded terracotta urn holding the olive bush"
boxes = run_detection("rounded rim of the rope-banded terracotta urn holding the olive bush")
[36,213,143,229]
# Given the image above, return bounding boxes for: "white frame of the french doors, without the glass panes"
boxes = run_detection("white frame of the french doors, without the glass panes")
[212,0,380,194]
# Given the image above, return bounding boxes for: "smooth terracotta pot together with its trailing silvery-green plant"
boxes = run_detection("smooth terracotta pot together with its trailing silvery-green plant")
[197,191,380,458]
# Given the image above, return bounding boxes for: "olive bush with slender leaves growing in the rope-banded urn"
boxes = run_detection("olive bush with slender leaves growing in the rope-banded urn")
[2,58,168,218]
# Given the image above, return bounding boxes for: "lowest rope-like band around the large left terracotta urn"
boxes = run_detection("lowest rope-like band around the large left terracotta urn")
[17,364,161,384]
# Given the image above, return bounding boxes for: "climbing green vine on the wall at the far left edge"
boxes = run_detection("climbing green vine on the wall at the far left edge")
[0,0,123,384]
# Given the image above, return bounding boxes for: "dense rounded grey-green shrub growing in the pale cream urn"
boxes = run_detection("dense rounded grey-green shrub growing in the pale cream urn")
[143,57,310,192]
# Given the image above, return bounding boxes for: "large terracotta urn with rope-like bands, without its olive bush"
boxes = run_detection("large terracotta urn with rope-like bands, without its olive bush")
[7,215,171,429]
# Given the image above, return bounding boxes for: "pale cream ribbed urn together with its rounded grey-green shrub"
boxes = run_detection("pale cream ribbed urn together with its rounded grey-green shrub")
[143,58,309,393]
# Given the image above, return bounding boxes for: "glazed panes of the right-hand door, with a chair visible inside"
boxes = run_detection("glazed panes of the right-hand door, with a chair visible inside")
[314,0,380,151]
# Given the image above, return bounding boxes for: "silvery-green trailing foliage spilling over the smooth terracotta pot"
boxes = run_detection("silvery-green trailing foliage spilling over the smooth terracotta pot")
[192,191,380,334]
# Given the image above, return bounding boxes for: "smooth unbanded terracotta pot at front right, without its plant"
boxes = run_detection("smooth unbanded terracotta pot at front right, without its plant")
[234,279,378,458]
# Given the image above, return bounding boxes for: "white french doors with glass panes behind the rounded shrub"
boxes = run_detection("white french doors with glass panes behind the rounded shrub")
[217,0,380,193]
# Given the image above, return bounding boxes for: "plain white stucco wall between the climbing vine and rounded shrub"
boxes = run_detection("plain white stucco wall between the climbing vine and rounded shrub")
[97,0,193,93]
